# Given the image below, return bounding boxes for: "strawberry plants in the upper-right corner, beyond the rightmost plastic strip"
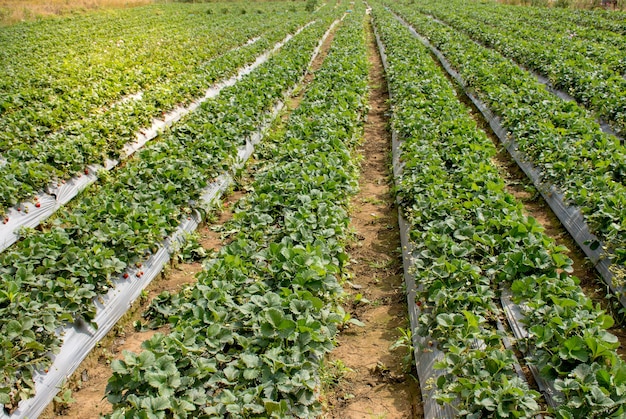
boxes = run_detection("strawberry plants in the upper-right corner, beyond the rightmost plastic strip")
[400,1,626,135]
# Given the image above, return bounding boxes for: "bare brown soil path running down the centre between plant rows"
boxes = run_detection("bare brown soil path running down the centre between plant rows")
[325,14,423,419]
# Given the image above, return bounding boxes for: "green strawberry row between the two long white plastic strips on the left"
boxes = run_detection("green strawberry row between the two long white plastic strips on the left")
[0,17,330,412]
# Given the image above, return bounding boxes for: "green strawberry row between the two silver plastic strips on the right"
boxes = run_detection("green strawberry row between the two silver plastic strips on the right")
[386,5,626,290]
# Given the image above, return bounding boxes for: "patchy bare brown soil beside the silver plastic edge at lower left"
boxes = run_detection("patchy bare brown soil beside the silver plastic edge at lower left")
[40,192,242,419]
